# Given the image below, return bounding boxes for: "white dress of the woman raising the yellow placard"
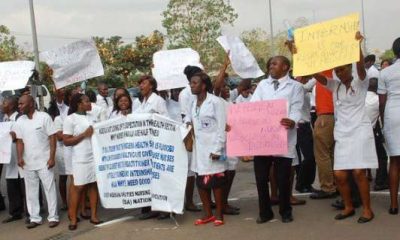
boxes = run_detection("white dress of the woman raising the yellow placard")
[326,76,378,170]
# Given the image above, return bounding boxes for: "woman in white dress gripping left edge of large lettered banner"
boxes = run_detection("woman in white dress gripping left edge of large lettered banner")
[63,93,102,230]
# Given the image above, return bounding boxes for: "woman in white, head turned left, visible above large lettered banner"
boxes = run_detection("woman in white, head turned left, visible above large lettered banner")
[133,75,168,117]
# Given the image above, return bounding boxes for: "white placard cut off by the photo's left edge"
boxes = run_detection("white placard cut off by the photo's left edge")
[0,61,35,91]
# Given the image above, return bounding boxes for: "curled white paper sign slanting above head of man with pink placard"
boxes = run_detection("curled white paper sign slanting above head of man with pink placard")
[217,36,265,79]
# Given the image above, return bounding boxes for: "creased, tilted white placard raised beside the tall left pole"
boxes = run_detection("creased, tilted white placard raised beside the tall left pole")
[40,40,104,89]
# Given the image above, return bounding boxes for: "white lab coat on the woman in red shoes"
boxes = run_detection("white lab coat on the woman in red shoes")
[190,93,226,175]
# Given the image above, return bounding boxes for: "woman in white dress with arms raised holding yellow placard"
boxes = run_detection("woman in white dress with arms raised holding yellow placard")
[314,32,378,223]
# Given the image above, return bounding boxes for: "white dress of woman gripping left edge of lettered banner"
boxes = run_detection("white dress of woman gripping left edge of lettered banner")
[63,113,96,186]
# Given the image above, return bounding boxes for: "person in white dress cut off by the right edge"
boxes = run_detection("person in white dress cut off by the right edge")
[378,38,400,215]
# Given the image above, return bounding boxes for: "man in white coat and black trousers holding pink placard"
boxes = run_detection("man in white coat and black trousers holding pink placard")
[251,56,304,224]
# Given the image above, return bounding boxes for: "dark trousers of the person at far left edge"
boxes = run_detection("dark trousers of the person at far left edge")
[6,178,28,217]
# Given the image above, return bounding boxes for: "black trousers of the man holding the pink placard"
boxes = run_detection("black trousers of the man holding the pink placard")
[254,156,292,218]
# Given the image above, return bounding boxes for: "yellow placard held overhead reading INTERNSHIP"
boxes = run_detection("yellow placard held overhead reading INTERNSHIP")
[293,13,360,76]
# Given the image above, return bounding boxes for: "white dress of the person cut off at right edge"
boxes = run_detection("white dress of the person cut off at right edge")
[378,59,400,156]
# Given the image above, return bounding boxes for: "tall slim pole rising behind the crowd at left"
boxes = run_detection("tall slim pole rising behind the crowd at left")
[29,0,44,111]
